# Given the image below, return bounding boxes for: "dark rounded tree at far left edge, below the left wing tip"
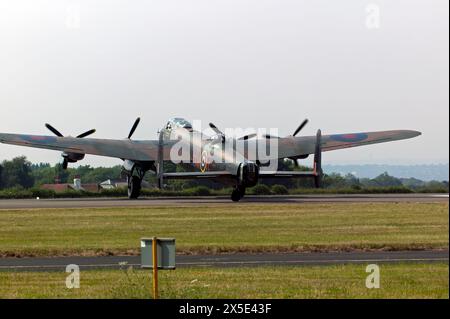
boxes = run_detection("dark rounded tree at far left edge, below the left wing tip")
[1,156,34,188]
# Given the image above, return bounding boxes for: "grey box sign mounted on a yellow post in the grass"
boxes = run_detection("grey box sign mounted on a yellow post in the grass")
[141,236,175,299]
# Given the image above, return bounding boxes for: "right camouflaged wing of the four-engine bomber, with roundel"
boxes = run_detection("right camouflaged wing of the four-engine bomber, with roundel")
[278,130,421,158]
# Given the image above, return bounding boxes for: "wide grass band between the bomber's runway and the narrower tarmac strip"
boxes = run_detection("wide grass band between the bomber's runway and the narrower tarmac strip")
[0,203,449,256]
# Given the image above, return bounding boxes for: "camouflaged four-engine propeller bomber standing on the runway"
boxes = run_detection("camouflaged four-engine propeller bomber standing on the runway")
[0,118,421,201]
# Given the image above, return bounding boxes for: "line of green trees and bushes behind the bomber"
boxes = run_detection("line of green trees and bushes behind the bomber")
[0,156,449,192]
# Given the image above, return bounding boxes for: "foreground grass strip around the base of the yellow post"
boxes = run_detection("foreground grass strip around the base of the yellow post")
[0,263,449,298]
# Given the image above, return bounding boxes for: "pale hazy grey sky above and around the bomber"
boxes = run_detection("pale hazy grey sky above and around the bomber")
[0,0,449,165]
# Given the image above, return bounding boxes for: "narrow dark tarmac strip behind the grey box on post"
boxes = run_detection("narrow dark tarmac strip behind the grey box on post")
[0,250,449,271]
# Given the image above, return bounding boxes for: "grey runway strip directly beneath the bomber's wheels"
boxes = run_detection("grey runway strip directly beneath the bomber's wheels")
[0,194,449,209]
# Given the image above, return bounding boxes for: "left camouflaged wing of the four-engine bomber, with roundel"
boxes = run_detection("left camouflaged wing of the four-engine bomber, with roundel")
[0,133,169,161]
